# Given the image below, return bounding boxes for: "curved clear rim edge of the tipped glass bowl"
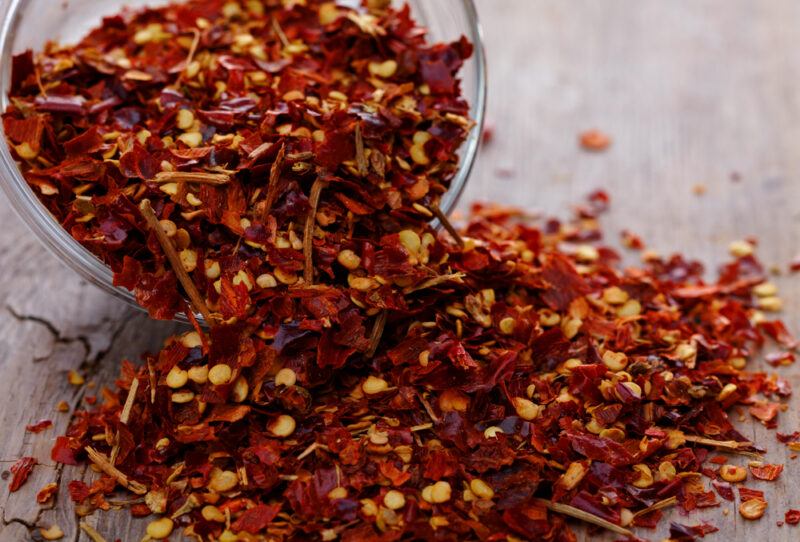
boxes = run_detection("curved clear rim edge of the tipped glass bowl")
[0,0,487,321]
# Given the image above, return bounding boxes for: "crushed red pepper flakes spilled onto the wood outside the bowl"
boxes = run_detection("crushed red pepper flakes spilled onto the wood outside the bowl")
[53,197,797,542]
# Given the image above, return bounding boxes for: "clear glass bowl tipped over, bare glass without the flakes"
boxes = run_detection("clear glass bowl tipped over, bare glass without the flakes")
[0,0,486,307]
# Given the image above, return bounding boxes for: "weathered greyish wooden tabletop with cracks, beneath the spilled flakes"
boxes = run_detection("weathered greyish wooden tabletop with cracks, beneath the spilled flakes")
[0,0,800,541]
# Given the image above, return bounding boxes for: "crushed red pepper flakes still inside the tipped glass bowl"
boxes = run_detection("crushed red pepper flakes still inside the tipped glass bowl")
[3,0,473,321]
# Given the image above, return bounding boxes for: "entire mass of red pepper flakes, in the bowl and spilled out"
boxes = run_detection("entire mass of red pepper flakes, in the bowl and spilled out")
[3,0,800,542]
